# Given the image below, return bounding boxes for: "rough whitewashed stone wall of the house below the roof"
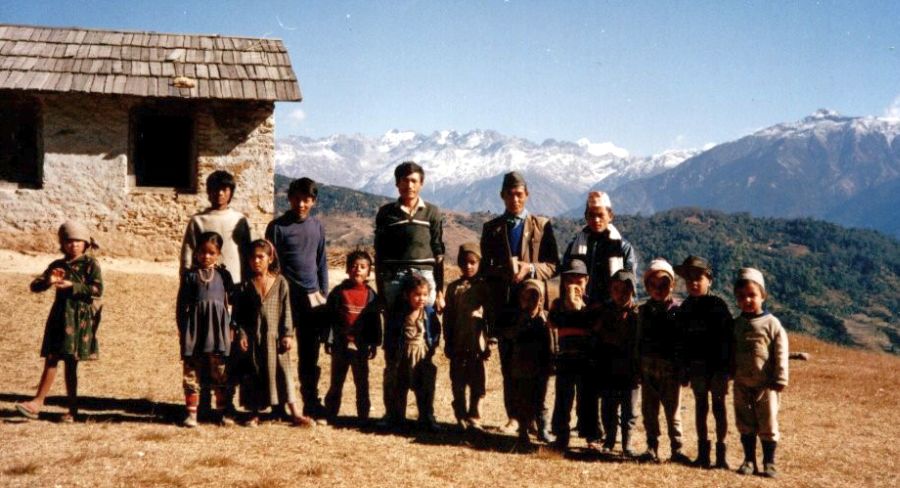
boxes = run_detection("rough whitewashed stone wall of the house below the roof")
[0,94,275,259]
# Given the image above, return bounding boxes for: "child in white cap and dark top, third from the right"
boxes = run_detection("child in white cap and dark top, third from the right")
[637,258,690,464]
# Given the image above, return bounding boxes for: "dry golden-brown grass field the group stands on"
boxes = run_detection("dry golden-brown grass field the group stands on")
[0,253,900,488]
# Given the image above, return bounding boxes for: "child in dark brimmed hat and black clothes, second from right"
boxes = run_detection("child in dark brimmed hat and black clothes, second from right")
[675,256,733,469]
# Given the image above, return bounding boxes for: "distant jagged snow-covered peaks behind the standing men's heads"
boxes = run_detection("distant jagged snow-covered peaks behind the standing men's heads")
[275,130,700,215]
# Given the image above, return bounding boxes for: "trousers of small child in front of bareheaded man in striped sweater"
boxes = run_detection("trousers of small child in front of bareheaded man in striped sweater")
[384,342,437,422]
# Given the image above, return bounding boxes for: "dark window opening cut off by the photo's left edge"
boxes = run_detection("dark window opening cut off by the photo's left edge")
[0,95,44,188]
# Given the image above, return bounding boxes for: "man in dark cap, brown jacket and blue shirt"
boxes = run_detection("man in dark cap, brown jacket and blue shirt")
[481,171,559,441]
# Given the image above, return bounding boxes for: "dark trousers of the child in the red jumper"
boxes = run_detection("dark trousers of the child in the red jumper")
[325,344,372,419]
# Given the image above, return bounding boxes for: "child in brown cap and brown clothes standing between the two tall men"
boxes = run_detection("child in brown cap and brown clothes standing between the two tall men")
[444,242,492,430]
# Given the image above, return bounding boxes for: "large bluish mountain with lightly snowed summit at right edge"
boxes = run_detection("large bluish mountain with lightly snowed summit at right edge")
[611,110,900,236]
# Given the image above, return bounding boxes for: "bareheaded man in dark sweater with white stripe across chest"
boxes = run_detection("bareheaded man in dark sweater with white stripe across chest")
[375,161,444,424]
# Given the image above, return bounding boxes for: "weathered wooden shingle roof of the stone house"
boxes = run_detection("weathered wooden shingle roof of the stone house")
[0,24,302,101]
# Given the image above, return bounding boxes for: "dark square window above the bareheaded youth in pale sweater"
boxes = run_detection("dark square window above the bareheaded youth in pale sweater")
[131,109,195,189]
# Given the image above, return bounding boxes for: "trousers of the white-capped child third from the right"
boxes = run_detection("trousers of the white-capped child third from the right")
[641,358,683,452]
